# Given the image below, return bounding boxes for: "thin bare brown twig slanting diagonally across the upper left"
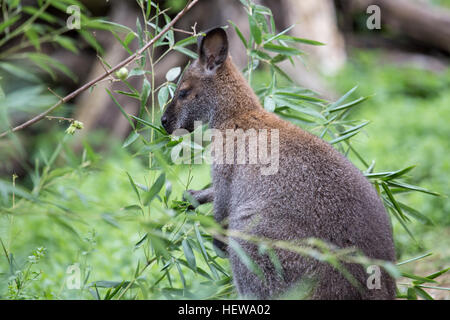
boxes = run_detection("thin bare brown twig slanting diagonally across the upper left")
[0,0,199,138]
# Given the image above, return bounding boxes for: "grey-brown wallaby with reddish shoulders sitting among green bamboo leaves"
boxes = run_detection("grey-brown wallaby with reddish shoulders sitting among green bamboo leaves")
[161,28,396,299]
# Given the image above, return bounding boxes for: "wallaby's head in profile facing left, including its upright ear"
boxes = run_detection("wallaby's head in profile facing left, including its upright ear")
[161,28,228,134]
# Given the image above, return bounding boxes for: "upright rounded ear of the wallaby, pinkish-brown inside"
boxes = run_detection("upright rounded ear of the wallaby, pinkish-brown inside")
[198,28,228,72]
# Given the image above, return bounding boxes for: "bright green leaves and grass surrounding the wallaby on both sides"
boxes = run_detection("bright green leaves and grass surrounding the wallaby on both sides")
[0,1,450,299]
